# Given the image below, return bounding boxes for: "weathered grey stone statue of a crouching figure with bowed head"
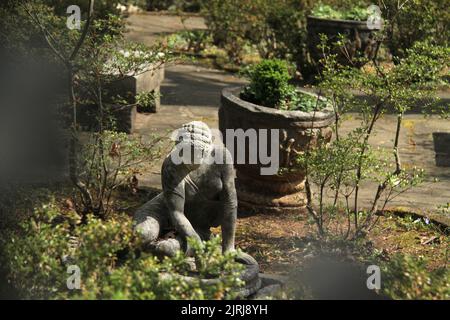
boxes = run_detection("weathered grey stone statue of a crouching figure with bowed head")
[135,121,250,264]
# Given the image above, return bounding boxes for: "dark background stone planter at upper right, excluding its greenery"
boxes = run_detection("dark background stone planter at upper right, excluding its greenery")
[307,16,379,68]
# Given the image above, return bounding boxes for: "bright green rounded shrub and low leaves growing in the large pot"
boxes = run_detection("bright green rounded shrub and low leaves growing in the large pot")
[241,59,326,112]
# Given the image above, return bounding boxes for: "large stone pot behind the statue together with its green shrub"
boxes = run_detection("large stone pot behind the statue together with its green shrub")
[219,60,334,212]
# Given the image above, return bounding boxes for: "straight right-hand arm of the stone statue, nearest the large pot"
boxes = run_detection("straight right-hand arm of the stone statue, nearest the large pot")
[221,164,237,252]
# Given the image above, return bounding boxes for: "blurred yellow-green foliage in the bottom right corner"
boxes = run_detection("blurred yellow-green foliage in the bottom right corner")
[380,254,450,300]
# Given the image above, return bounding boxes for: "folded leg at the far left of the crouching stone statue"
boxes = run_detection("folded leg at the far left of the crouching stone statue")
[134,193,168,244]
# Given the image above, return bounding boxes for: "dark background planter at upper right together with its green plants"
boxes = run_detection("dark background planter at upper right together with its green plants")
[307,3,380,70]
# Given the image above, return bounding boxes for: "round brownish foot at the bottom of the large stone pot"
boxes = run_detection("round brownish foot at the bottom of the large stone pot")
[236,185,307,213]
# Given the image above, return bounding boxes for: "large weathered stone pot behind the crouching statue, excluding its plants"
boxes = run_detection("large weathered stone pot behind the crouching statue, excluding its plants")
[219,87,334,212]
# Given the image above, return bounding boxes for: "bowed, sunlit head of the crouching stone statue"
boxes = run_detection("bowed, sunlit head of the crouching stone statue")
[175,121,213,169]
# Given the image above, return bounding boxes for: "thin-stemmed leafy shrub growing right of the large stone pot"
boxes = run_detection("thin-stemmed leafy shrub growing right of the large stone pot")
[299,39,449,239]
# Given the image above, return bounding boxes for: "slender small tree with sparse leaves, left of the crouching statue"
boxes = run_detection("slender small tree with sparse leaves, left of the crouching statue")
[19,0,171,215]
